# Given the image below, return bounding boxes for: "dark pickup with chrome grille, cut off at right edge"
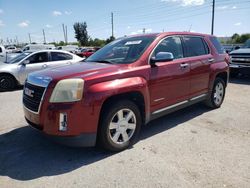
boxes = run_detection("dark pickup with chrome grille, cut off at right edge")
[229,39,250,77]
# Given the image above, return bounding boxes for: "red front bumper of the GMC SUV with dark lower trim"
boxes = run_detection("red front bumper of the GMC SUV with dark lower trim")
[24,101,98,147]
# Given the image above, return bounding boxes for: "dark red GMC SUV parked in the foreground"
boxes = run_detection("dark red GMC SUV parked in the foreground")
[23,32,229,151]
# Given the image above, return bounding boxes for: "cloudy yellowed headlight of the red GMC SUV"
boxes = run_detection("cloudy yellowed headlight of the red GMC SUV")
[50,78,84,103]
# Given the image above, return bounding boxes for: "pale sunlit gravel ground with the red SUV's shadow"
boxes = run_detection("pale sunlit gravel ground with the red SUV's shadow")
[0,78,250,188]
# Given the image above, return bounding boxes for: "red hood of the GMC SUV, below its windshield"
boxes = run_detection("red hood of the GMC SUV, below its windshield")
[30,62,124,80]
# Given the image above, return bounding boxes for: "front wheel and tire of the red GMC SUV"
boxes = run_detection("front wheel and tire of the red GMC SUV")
[98,100,142,152]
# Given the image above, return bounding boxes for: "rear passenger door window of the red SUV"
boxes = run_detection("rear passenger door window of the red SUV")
[183,37,209,57]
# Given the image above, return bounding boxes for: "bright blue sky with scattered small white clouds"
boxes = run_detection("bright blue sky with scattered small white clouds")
[0,0,250,43]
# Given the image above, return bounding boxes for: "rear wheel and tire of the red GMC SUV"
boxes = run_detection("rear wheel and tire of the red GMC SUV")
[206,77,226,109]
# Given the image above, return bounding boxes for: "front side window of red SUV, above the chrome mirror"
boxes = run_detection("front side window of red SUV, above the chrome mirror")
[153,37,183,59]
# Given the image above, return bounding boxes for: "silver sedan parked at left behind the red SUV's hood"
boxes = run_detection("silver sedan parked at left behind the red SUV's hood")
[0,50,82,91]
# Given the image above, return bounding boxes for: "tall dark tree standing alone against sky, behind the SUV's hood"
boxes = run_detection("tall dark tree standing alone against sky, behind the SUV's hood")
[74,22,89,46]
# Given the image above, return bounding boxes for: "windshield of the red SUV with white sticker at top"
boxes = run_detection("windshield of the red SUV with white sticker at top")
[85,36,155,64]
